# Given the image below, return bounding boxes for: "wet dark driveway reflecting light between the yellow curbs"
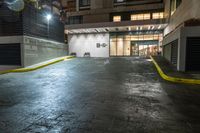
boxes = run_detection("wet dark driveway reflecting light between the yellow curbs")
[0,58,200,133]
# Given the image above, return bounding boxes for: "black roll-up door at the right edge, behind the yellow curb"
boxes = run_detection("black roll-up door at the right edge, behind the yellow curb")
[186,37,200,71]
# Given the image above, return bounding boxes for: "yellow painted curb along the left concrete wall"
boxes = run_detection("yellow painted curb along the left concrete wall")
[0,56,74,75]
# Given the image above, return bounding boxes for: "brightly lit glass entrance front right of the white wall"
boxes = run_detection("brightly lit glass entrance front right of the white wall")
[110,34,162,56]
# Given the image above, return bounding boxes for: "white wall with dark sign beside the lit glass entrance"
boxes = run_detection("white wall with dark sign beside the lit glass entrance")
[68,33,109,57]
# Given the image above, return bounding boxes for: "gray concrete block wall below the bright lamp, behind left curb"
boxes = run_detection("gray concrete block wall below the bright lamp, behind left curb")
[22,36,67,67]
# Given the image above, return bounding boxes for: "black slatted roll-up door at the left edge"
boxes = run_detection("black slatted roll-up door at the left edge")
[0,44,21,66]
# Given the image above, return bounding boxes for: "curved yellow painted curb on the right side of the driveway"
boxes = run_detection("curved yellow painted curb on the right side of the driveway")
[150,56,200,85]
